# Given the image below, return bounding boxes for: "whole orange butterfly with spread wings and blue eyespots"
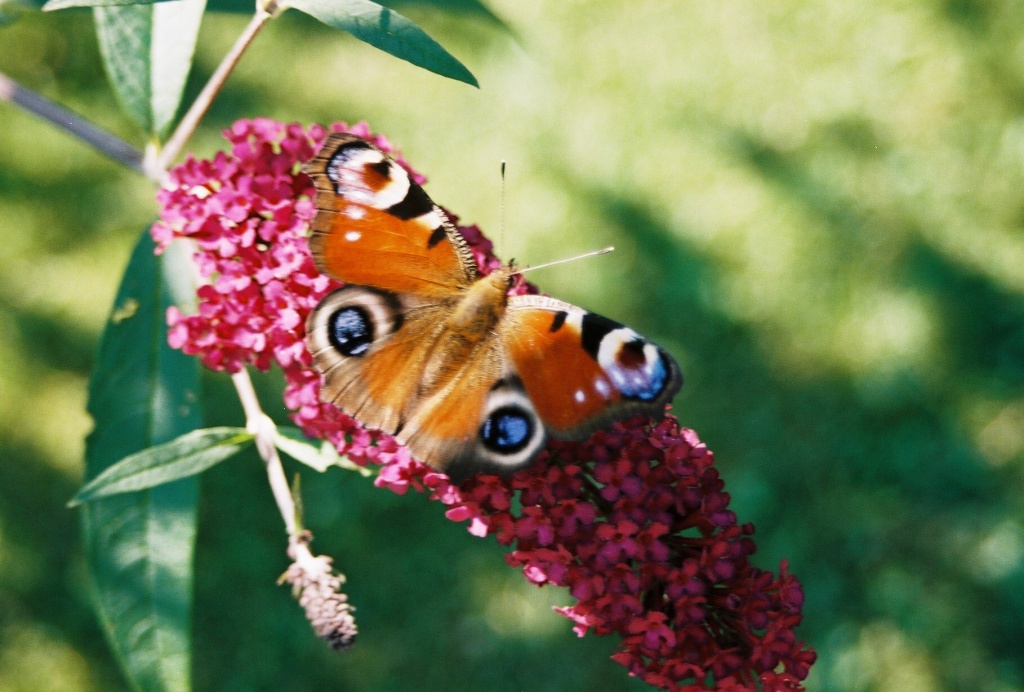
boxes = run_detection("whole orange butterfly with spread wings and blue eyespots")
[305,133,682,480]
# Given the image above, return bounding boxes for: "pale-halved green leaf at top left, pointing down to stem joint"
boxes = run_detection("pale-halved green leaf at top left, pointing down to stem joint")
[83,0,206,138]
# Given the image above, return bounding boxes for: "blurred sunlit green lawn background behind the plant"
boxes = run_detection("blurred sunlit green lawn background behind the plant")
[0,0,1024,690]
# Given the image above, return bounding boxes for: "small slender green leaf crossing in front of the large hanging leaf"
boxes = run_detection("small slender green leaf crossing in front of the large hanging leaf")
[71,428,253,506]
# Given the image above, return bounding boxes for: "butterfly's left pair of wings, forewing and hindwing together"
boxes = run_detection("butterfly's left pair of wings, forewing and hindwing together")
[304,133,478,458]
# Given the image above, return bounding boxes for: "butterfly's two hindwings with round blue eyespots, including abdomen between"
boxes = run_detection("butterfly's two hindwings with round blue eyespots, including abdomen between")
[306,285,545,481]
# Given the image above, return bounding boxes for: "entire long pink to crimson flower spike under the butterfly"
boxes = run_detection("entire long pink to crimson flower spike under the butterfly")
[153,119,815,690]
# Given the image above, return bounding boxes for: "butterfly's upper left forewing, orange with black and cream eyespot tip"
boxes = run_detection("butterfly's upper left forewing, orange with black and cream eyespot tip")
[304,133,478,298]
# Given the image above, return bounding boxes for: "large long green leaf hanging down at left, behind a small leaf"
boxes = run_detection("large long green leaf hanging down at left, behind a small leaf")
[81,232,202,690]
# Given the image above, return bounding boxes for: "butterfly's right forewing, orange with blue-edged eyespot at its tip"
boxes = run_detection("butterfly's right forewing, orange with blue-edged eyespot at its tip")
[501,296,683,440]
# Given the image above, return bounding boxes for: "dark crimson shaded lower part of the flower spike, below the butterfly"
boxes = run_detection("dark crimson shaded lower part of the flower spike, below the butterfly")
[438,427,815,690]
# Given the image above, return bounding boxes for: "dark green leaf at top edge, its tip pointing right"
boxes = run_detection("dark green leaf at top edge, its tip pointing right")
[288,0,479,87]
